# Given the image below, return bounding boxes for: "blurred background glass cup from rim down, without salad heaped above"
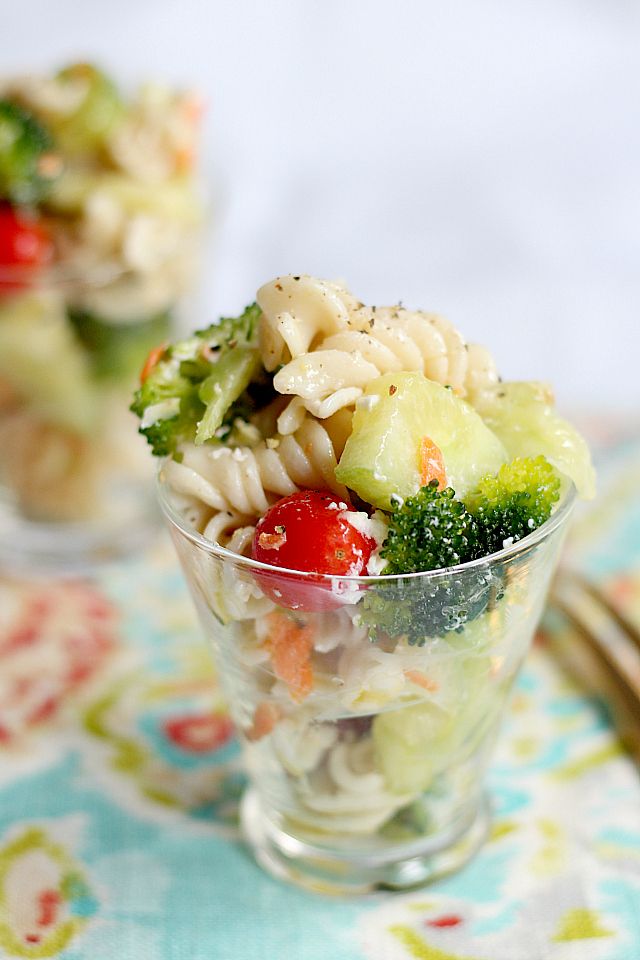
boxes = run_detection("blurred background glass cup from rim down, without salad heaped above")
[0,262,188,573]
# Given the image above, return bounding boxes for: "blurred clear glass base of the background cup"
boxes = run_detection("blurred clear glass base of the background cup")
[0,495,161,576]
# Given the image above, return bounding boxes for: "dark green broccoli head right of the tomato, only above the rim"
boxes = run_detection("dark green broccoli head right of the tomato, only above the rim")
[380,480,476,573]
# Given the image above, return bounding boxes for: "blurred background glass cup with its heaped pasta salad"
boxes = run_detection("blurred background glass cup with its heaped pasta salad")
[0,63,204,573]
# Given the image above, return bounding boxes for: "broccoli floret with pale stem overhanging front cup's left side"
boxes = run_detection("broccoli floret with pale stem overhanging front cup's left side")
[131,304,260,457]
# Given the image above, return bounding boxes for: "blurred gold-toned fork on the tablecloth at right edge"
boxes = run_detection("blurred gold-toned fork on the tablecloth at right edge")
[548,568,640,763]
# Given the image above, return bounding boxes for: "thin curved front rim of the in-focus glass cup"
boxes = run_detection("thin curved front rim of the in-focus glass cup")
[156,460,577,586]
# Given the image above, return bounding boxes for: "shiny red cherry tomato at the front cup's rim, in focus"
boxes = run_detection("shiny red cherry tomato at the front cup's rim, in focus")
[252,490,376,611]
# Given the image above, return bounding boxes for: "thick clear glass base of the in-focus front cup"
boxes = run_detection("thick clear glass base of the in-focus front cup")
[240,789,490,896]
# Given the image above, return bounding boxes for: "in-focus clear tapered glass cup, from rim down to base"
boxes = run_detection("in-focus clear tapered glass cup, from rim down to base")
[159,472,574,894]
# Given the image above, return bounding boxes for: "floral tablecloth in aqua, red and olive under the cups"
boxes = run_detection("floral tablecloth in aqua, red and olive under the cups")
[0,436,640,960]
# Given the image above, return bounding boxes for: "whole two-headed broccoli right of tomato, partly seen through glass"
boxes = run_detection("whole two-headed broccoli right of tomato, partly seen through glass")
[360,456,560,644]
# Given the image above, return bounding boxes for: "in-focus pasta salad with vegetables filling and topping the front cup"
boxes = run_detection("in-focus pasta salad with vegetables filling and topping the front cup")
[132,275,594,846]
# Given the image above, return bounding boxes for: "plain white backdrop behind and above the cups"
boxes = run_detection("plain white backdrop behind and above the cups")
[0,0,640,411]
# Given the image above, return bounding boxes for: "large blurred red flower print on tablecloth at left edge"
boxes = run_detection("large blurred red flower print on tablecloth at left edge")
[0,581,119,747]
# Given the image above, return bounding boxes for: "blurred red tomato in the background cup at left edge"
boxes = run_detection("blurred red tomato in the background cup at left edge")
[0,203,53,293]
